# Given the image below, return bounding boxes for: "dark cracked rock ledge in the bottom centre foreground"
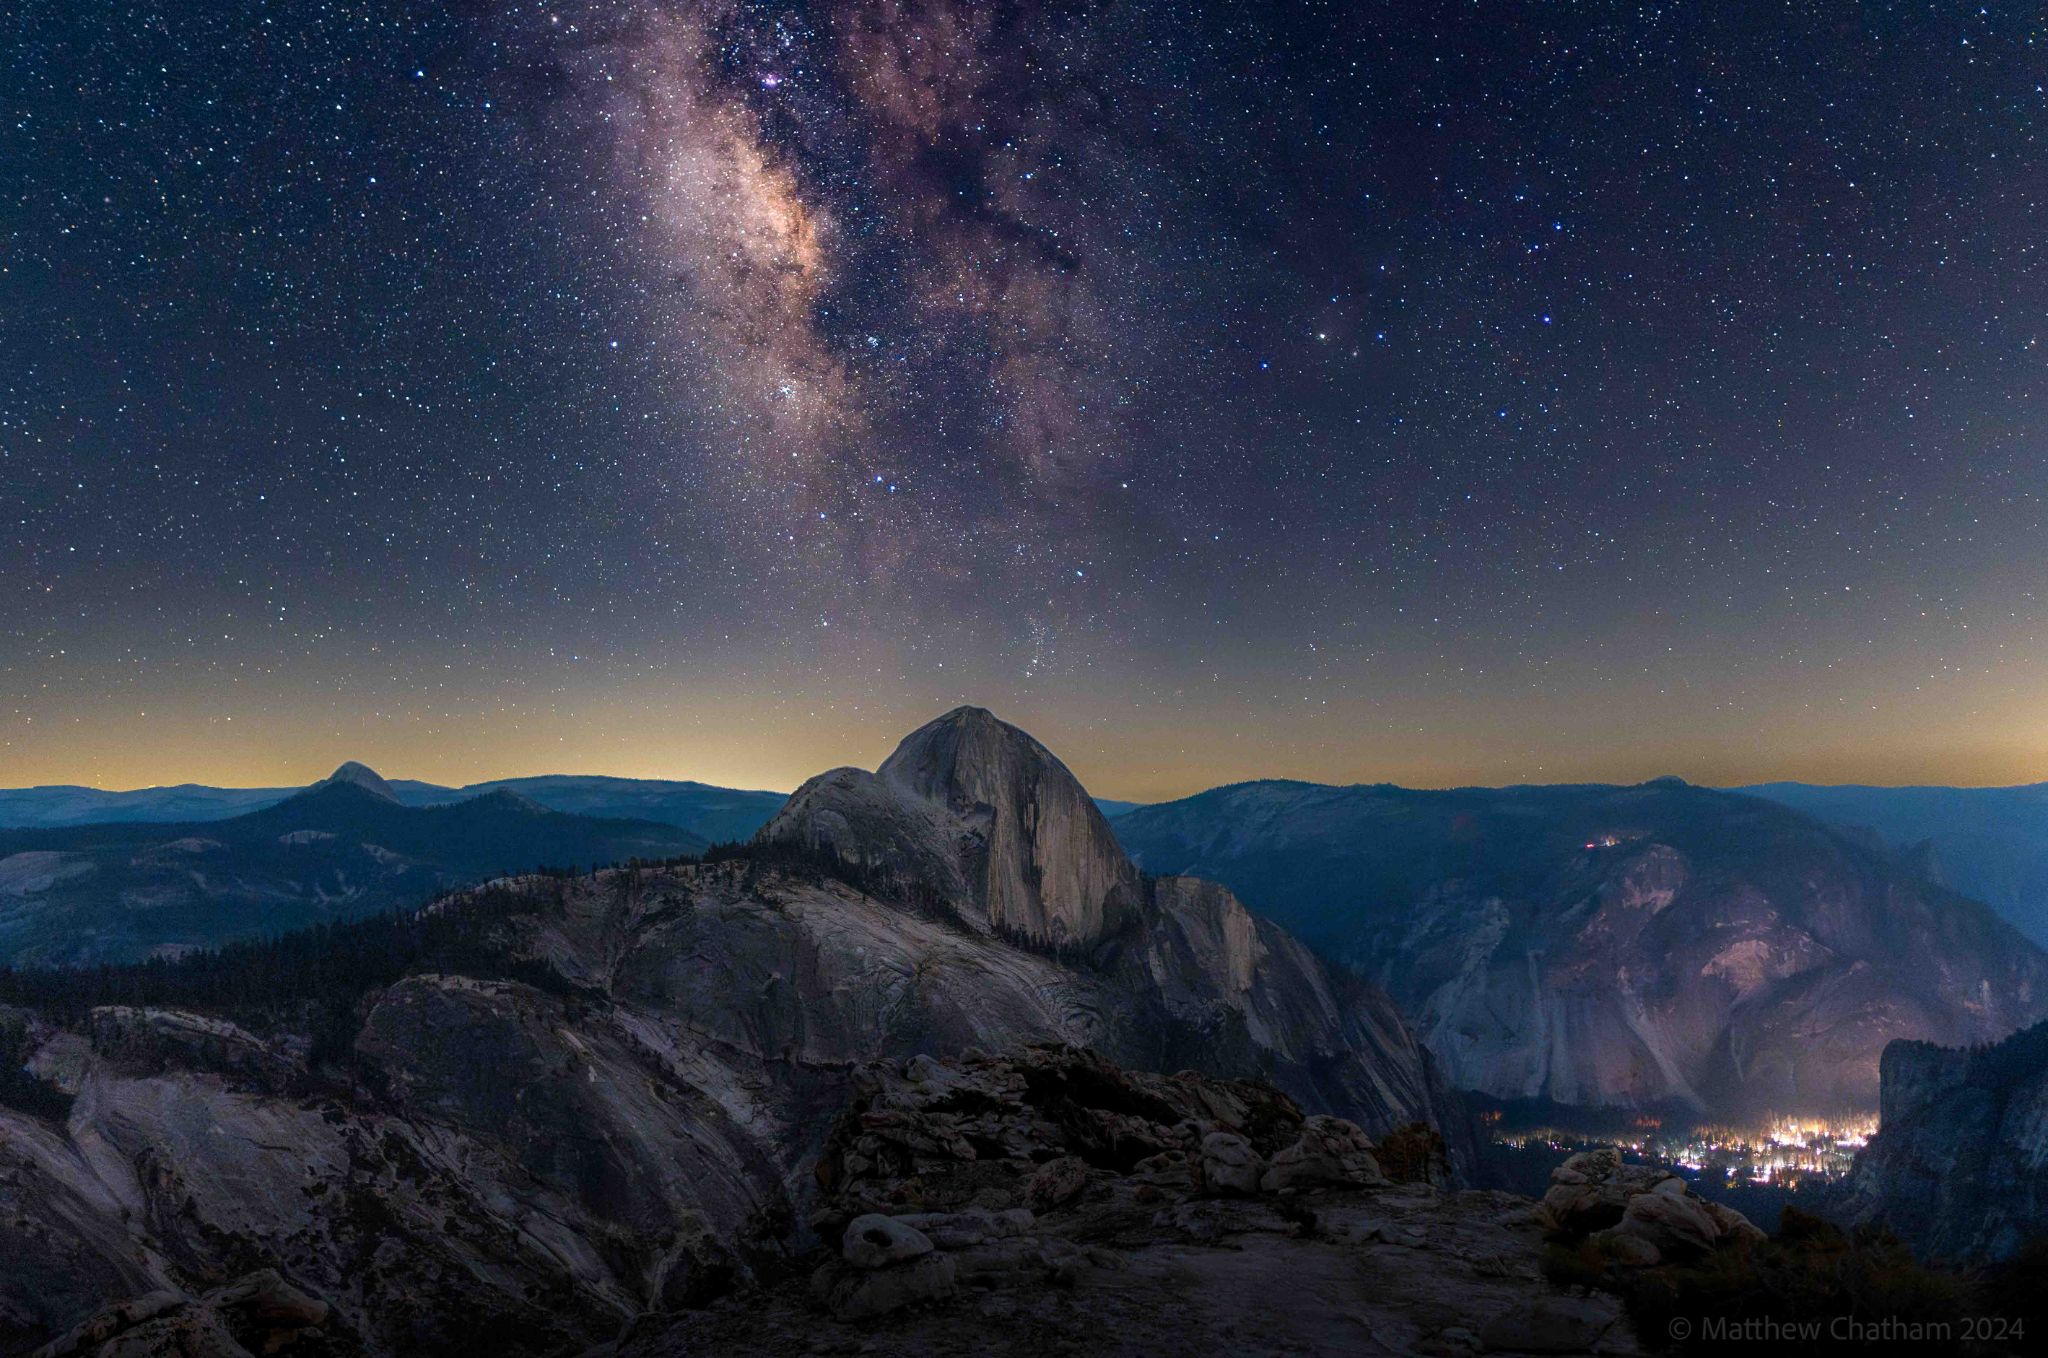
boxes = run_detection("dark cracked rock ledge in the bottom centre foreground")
[608,1049,1640,1358]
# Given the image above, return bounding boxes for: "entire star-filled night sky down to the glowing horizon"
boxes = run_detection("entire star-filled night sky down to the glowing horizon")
[0,0,2048,799]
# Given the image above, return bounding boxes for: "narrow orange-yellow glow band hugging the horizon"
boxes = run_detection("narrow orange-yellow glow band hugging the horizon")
[0,696,2048,801]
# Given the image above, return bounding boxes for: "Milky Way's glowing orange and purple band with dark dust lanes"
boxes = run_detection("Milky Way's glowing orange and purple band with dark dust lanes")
[532,4,1241,622]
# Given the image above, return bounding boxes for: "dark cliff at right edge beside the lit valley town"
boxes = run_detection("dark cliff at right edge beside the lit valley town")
[1847,1024,2048,1260]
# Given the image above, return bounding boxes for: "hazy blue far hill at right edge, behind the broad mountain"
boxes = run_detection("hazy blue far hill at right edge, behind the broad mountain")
[1739,782,2048,946]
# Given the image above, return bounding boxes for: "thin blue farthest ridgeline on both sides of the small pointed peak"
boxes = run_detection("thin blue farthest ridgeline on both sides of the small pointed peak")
[0,774,784,844]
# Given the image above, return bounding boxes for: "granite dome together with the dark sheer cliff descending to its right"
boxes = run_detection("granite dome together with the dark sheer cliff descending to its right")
[760,707,1470,1153]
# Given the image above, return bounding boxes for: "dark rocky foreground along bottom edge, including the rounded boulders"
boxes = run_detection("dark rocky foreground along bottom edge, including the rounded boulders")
[24,1047,1753,1358]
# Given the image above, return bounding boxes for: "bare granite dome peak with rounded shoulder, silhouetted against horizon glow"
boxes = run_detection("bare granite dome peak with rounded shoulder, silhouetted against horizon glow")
[762,707,1139,948]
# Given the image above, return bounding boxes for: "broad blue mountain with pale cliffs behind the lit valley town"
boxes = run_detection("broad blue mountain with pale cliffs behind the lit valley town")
[1112,778,2048,1116]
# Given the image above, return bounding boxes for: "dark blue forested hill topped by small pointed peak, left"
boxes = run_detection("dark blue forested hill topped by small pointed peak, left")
[0,764,709,967]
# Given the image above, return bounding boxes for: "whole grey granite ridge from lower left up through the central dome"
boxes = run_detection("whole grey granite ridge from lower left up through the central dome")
[0,715,1468,1358]
